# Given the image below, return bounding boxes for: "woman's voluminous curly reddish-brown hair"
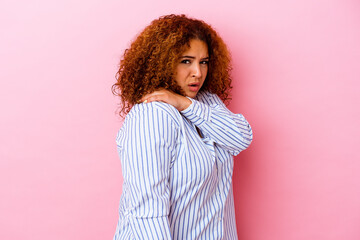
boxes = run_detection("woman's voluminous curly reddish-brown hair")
[112,14,232,115]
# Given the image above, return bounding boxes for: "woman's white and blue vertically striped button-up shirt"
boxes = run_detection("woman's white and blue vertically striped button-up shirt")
[113,92,252,240]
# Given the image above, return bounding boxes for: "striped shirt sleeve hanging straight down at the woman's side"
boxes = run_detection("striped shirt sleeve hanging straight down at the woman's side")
[118,103,176,239]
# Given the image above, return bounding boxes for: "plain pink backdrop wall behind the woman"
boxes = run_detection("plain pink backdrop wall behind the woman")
[0,0,360,240]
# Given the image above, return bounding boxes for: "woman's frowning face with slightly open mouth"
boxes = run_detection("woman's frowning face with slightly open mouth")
[175,39,209,98]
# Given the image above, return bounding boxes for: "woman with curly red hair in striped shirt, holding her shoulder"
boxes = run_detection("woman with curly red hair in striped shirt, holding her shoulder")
[113,15,252,240]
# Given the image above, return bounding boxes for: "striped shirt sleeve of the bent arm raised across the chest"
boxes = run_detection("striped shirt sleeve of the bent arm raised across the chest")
[181,93,253,156]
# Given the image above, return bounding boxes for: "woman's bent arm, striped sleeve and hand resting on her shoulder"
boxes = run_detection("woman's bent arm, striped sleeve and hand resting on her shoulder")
[142,89,252,156]
